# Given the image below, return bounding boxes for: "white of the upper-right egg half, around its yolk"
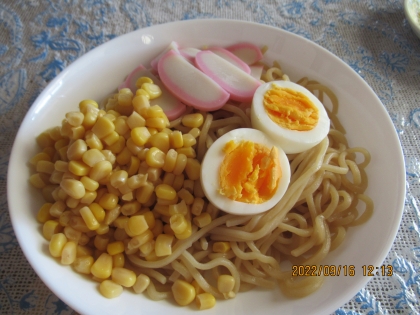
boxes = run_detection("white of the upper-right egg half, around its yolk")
[251,81,330,154]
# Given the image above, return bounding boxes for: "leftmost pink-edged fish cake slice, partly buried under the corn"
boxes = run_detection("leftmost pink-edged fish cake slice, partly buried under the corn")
[118,65,187,120]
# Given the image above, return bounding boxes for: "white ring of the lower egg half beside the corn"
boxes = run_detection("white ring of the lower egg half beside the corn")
[201,128,290,215]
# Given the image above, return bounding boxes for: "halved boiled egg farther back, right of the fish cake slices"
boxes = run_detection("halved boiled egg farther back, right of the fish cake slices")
[251,81,330,154]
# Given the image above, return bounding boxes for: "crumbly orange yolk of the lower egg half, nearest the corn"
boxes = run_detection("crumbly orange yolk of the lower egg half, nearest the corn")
[219,140,282,204]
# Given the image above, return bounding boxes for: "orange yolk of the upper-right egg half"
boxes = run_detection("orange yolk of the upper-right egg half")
[264,84,319,131]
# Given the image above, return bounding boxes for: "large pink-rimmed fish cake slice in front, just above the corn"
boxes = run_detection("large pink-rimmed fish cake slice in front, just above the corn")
[158,50,230,111]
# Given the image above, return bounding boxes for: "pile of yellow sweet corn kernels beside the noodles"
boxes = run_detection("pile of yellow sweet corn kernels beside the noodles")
[30,77,234,309]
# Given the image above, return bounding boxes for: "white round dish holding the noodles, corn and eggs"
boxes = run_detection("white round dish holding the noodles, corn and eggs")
[8,20,405,315]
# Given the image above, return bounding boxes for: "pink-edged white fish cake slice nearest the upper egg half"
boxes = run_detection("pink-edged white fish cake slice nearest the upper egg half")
[195,50,261,102]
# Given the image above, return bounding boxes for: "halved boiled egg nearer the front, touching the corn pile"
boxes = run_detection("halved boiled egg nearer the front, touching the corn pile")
[201,128,290,215]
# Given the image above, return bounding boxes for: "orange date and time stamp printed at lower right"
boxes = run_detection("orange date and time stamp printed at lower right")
[292,265,394,277]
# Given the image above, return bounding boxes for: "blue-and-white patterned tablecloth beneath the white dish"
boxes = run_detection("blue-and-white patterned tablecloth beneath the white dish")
[0,0,420,315]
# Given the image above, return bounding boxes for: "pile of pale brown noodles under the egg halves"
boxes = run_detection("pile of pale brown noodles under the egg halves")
[128,58,373,300]
